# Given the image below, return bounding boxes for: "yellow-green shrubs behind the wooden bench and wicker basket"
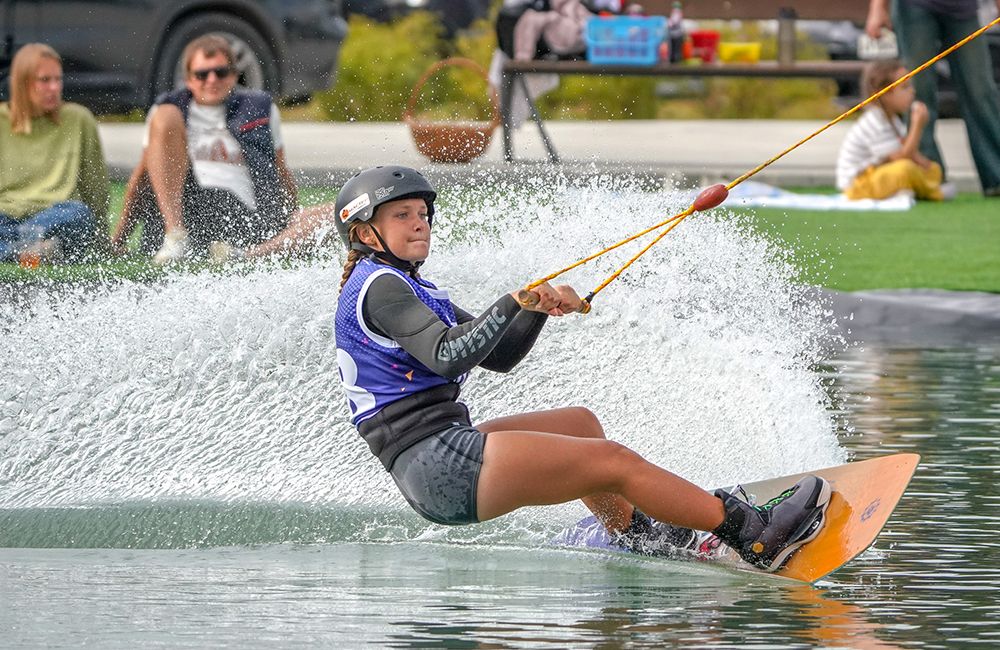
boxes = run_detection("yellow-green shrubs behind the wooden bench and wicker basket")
[307,7,839,121]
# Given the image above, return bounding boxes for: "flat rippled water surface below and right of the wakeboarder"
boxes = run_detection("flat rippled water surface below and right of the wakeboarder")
[0,346,1000,648]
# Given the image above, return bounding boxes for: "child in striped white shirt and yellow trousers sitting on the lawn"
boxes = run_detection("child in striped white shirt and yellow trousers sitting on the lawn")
[837,60,944,201]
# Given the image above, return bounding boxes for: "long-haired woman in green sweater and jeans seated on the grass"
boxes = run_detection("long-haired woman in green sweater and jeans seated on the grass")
[0,43,108,261]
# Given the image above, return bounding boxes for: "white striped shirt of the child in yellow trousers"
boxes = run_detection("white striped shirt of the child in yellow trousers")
[837,106,906,190]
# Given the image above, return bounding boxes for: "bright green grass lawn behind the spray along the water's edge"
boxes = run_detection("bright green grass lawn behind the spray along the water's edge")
[0,183,1000,293]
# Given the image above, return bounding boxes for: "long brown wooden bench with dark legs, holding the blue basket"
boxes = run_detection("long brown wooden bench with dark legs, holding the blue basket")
[500,0,868,163]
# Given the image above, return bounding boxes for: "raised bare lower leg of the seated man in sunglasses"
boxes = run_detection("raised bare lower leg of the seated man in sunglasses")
[145,104,188,234]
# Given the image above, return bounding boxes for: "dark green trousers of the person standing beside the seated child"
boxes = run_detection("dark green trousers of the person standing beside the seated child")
[892,0,1000,191]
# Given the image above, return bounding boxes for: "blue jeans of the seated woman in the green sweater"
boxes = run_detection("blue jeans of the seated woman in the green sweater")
[0,201,96,262]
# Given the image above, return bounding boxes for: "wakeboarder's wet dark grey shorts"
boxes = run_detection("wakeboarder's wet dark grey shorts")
[390,424,486,526]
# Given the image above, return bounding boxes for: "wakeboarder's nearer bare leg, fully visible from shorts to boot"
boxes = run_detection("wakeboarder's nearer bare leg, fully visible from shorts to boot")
[477,431,724,530]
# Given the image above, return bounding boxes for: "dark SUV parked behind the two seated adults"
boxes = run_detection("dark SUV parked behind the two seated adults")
[0,0,347,113]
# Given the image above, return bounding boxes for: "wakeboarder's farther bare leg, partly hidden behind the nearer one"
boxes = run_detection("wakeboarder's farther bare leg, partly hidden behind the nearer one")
[476,407,632,532]
